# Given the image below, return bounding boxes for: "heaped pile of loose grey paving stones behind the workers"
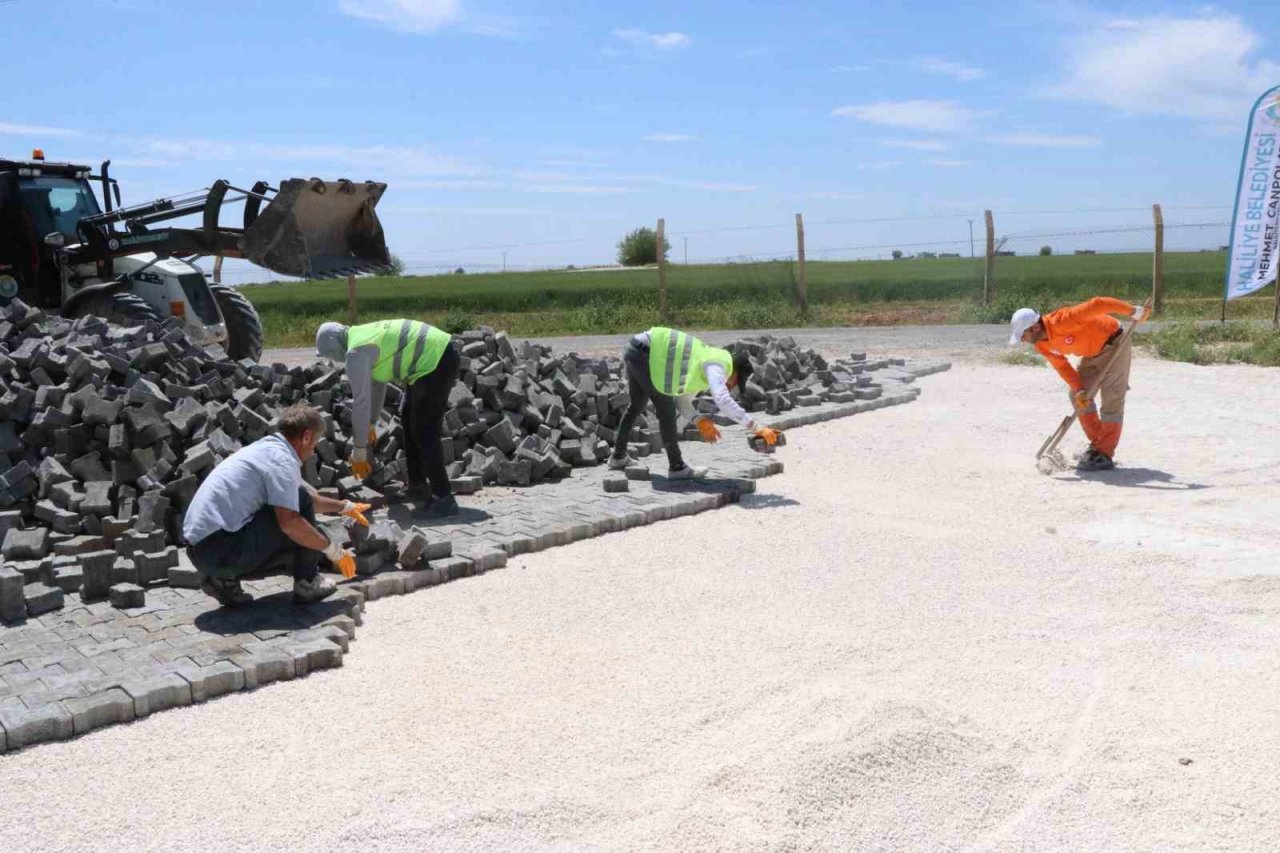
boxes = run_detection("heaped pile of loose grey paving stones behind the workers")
[0,300,911,621]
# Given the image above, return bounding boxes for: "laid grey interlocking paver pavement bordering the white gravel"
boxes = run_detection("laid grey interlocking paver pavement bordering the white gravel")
[0,362,948,752]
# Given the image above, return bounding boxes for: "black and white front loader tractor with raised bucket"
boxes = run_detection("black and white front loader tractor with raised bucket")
[0,150,390,361]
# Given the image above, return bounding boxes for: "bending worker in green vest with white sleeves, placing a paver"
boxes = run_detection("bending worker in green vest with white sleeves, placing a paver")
[609,327,778,480]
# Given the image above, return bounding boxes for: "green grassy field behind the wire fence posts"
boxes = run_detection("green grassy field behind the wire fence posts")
[242,252,1272,346]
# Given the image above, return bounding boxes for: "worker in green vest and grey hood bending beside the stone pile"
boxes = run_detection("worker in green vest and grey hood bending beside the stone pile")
[316,312,462,517]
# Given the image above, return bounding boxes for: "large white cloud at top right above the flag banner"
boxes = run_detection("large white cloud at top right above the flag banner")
[1050,12,1280,120]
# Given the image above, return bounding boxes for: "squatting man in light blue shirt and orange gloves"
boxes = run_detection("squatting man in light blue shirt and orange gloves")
[182,405,369,607]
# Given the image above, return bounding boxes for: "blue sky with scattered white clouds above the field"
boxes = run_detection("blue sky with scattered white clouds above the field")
[0,0,1280,277]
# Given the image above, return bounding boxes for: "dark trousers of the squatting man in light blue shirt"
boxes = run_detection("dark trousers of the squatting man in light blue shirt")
[187,489,324,580]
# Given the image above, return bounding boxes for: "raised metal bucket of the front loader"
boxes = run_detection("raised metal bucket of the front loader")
[239,178,390,278]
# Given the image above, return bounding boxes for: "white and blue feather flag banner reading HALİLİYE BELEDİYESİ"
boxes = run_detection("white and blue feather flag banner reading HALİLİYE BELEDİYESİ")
[1226,86,1280,300]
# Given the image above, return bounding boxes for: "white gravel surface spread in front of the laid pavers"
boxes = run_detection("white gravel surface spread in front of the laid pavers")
[0,343,1280,852]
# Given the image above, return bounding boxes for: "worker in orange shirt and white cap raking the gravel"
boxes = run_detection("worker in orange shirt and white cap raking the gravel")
[1009,296,1147,471]
